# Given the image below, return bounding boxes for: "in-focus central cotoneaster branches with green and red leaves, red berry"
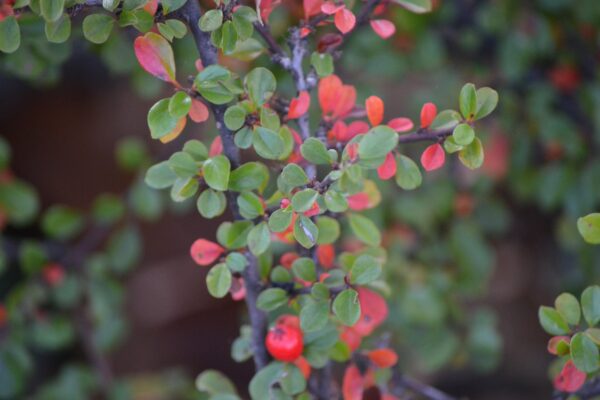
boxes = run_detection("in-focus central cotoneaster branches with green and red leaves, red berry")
[0,0,498,400]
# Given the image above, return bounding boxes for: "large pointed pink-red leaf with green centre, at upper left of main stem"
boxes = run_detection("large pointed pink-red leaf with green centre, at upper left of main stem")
[134,32,177,85]
